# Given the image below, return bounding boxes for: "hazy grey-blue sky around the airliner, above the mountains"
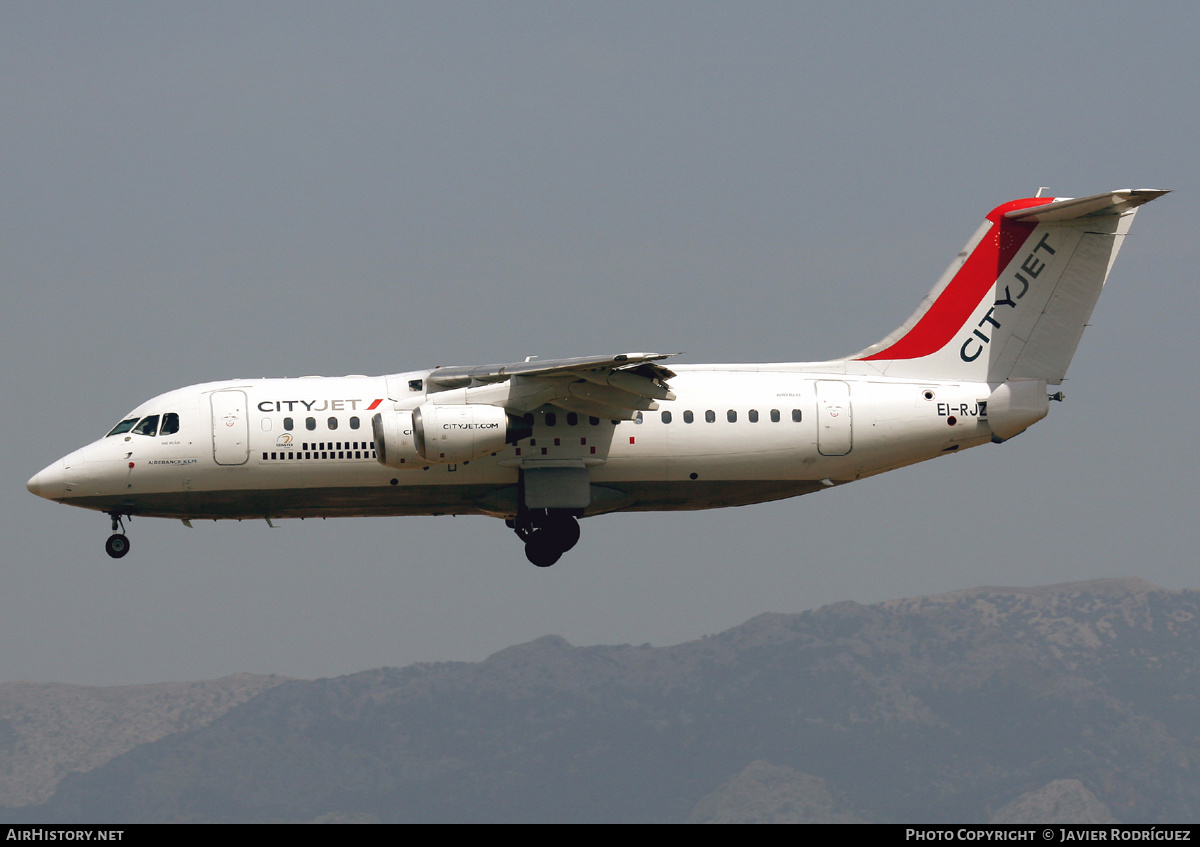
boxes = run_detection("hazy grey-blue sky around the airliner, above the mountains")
[0,1,1200,684]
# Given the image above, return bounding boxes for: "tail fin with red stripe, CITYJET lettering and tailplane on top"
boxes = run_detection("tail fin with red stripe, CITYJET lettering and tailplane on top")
[851,190,1166,384]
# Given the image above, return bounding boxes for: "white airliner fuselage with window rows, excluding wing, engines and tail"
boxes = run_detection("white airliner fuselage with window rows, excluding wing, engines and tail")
[23,365,1012,519]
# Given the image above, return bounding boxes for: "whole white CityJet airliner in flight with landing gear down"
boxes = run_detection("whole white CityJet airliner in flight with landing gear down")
[28,190,1166,567]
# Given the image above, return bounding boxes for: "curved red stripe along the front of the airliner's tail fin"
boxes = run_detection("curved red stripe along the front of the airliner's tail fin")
[863,197,1054,361]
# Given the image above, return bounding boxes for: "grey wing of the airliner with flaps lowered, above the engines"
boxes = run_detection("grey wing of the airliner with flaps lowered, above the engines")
[426,353,679,420]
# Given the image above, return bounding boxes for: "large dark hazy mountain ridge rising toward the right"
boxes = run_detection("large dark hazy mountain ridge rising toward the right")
[10,579,1200,823]
